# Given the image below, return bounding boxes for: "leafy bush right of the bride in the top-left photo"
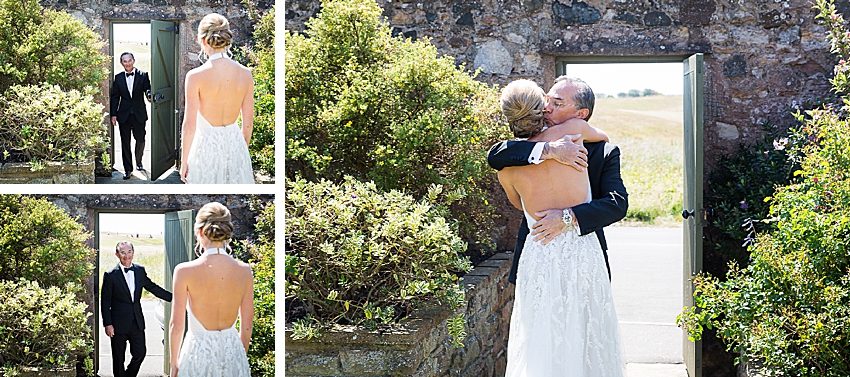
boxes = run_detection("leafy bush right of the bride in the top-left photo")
[237,0,275,176]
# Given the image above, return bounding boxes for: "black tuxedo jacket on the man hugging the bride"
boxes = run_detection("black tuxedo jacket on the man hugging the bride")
[487,140,629,283]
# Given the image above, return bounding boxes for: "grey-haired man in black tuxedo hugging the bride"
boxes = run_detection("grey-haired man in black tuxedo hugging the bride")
[487,76,629,283]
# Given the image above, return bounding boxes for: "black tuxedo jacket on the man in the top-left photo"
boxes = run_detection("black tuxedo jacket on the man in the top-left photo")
[109,68,151,123]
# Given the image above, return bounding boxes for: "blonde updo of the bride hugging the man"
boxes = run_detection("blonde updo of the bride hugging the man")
[499,80,545,138]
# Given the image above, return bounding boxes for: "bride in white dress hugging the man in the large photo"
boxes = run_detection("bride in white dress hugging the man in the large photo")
[499,80,625,377]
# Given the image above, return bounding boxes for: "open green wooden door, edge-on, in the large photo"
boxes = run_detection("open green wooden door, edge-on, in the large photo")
[682,54,705,377]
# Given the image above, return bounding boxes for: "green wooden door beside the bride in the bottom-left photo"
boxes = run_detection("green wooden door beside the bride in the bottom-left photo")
[163,209,195,374]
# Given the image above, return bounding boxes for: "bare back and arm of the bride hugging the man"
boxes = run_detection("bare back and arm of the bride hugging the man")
[499,119,607,220]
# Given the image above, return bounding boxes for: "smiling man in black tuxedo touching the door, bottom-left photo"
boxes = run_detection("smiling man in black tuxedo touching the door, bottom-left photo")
[100,241,171,377]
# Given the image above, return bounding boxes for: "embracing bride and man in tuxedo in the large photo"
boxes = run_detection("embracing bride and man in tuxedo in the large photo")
[488,76,628,377]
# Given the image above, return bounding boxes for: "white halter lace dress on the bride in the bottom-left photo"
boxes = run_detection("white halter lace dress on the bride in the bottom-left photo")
[177,249,251,377]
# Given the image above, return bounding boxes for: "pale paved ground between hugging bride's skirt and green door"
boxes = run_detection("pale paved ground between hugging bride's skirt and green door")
[605,227,687,377]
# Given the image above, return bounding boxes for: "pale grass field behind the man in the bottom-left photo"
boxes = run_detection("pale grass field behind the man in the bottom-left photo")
[98,232,165,299]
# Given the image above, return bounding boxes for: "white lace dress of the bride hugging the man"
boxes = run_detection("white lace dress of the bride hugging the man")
[506,194,626,377]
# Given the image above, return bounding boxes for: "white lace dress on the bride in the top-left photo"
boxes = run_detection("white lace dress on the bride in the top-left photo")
[186,111,254,184]
